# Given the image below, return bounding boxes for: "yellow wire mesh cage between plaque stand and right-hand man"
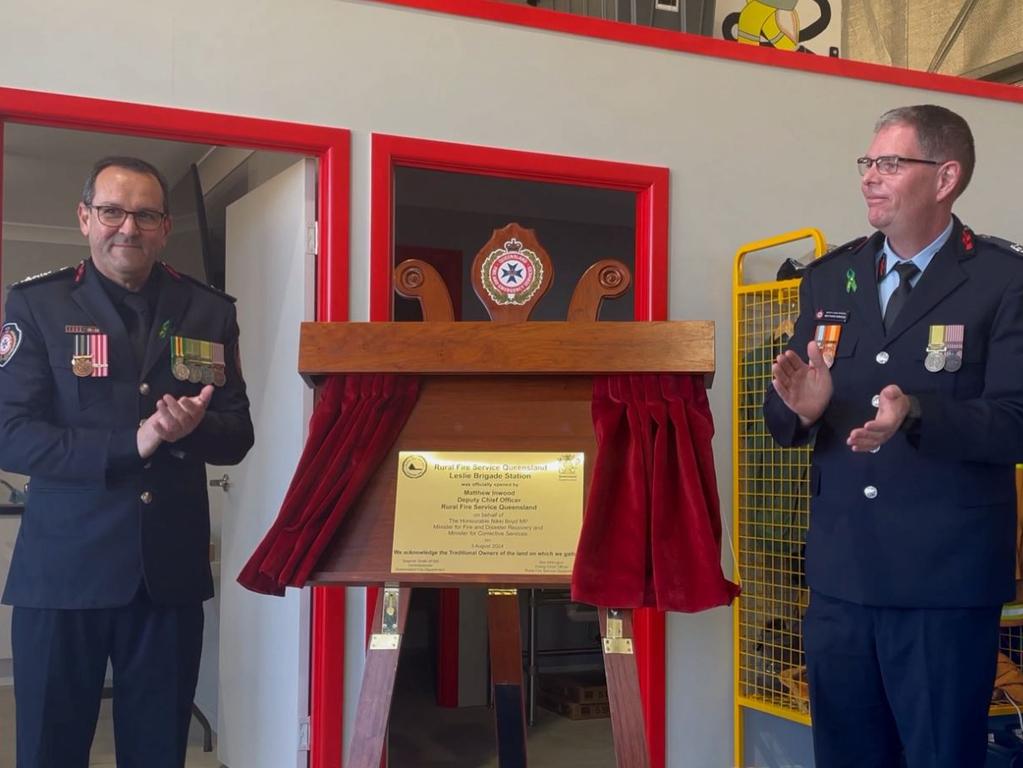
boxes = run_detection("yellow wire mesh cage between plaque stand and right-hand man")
[732,229,827,740]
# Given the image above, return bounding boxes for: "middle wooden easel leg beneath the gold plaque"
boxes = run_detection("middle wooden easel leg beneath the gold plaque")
[487,589,526,768]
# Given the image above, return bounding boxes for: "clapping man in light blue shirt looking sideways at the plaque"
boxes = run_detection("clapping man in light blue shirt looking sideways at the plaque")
[764,105,1023,768]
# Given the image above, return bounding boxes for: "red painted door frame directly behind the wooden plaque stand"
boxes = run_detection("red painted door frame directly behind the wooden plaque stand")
[351,134,669,768]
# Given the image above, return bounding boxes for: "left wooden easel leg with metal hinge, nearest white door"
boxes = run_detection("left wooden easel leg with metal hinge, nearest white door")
[345,585,412,768]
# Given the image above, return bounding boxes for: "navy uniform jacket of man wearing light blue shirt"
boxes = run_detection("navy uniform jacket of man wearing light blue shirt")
[764,220,1023,607]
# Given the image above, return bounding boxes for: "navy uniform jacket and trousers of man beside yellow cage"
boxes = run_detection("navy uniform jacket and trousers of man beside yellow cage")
[764,219,1023,768]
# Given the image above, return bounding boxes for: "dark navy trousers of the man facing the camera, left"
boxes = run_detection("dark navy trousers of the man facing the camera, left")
[11,588,203,768]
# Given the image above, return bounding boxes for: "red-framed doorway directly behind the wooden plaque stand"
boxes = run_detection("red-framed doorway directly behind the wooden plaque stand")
[367,135,668,766]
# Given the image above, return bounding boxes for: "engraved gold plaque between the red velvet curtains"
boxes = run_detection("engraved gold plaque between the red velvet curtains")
[391,451,583,576]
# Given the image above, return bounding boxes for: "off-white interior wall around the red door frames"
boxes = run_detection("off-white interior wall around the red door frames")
[0,0,1023,768]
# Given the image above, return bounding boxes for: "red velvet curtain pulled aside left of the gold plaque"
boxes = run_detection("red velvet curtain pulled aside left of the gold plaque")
[238,373,419,595]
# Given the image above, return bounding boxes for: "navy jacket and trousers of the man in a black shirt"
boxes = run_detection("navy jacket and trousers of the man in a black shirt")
[0,262,253,768]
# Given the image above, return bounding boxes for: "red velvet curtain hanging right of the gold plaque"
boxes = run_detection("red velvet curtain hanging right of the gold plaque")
[572,374,739,612]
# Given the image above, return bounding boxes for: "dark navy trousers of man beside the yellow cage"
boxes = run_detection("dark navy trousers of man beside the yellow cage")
[803,592,1002,768]
